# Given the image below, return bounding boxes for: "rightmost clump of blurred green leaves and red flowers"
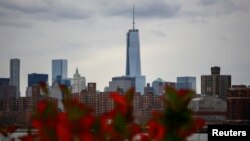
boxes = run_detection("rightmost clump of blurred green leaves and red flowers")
[148,88,205,141]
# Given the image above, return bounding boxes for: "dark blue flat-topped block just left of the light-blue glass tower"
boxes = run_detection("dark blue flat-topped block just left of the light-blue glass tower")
[28,73,48,87]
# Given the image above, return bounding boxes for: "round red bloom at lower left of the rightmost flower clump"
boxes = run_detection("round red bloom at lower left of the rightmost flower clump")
[148,120,166,140]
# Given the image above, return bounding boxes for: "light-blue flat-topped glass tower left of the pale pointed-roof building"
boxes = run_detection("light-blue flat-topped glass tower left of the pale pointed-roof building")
[52,59,68,83]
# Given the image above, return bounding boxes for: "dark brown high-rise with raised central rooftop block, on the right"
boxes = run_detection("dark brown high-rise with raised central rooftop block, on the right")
[201,66,231,101]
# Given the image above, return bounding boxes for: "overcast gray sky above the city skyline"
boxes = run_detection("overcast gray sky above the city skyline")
[0,0,250,96]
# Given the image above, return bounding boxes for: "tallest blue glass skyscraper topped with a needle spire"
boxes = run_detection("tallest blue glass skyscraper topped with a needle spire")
[126,7,146,94]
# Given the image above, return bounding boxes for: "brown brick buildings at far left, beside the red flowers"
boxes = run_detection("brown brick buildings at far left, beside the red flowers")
[0,85,58,128]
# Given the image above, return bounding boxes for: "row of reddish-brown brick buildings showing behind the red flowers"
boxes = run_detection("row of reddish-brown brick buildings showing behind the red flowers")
[0,83,163,127]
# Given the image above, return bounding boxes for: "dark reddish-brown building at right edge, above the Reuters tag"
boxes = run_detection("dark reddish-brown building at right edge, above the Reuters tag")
[227,85,250,124]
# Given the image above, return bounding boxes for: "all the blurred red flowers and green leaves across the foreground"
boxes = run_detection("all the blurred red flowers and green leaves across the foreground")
[0,84,205,141]
